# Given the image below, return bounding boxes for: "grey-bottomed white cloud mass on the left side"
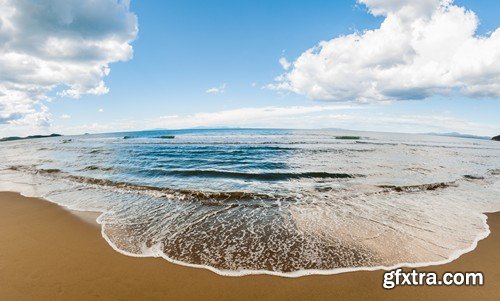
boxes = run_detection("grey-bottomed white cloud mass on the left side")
[0,0,138,127]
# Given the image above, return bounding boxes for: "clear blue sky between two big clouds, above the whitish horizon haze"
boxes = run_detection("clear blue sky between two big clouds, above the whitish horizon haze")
[51,0,379,123]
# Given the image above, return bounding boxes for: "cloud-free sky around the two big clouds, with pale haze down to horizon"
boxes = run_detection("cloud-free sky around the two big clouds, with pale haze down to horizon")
[0,0,500,135]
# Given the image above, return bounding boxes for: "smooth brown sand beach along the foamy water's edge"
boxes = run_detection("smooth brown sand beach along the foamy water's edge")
[0,192,500,300]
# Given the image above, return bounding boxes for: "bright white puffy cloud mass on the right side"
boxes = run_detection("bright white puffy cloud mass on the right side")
[269,0,500,102]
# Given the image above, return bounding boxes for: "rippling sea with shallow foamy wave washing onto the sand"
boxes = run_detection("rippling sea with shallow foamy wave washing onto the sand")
[0,129,500,277]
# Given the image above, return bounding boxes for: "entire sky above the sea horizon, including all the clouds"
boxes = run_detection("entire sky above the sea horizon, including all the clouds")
[0,0,500,136]
